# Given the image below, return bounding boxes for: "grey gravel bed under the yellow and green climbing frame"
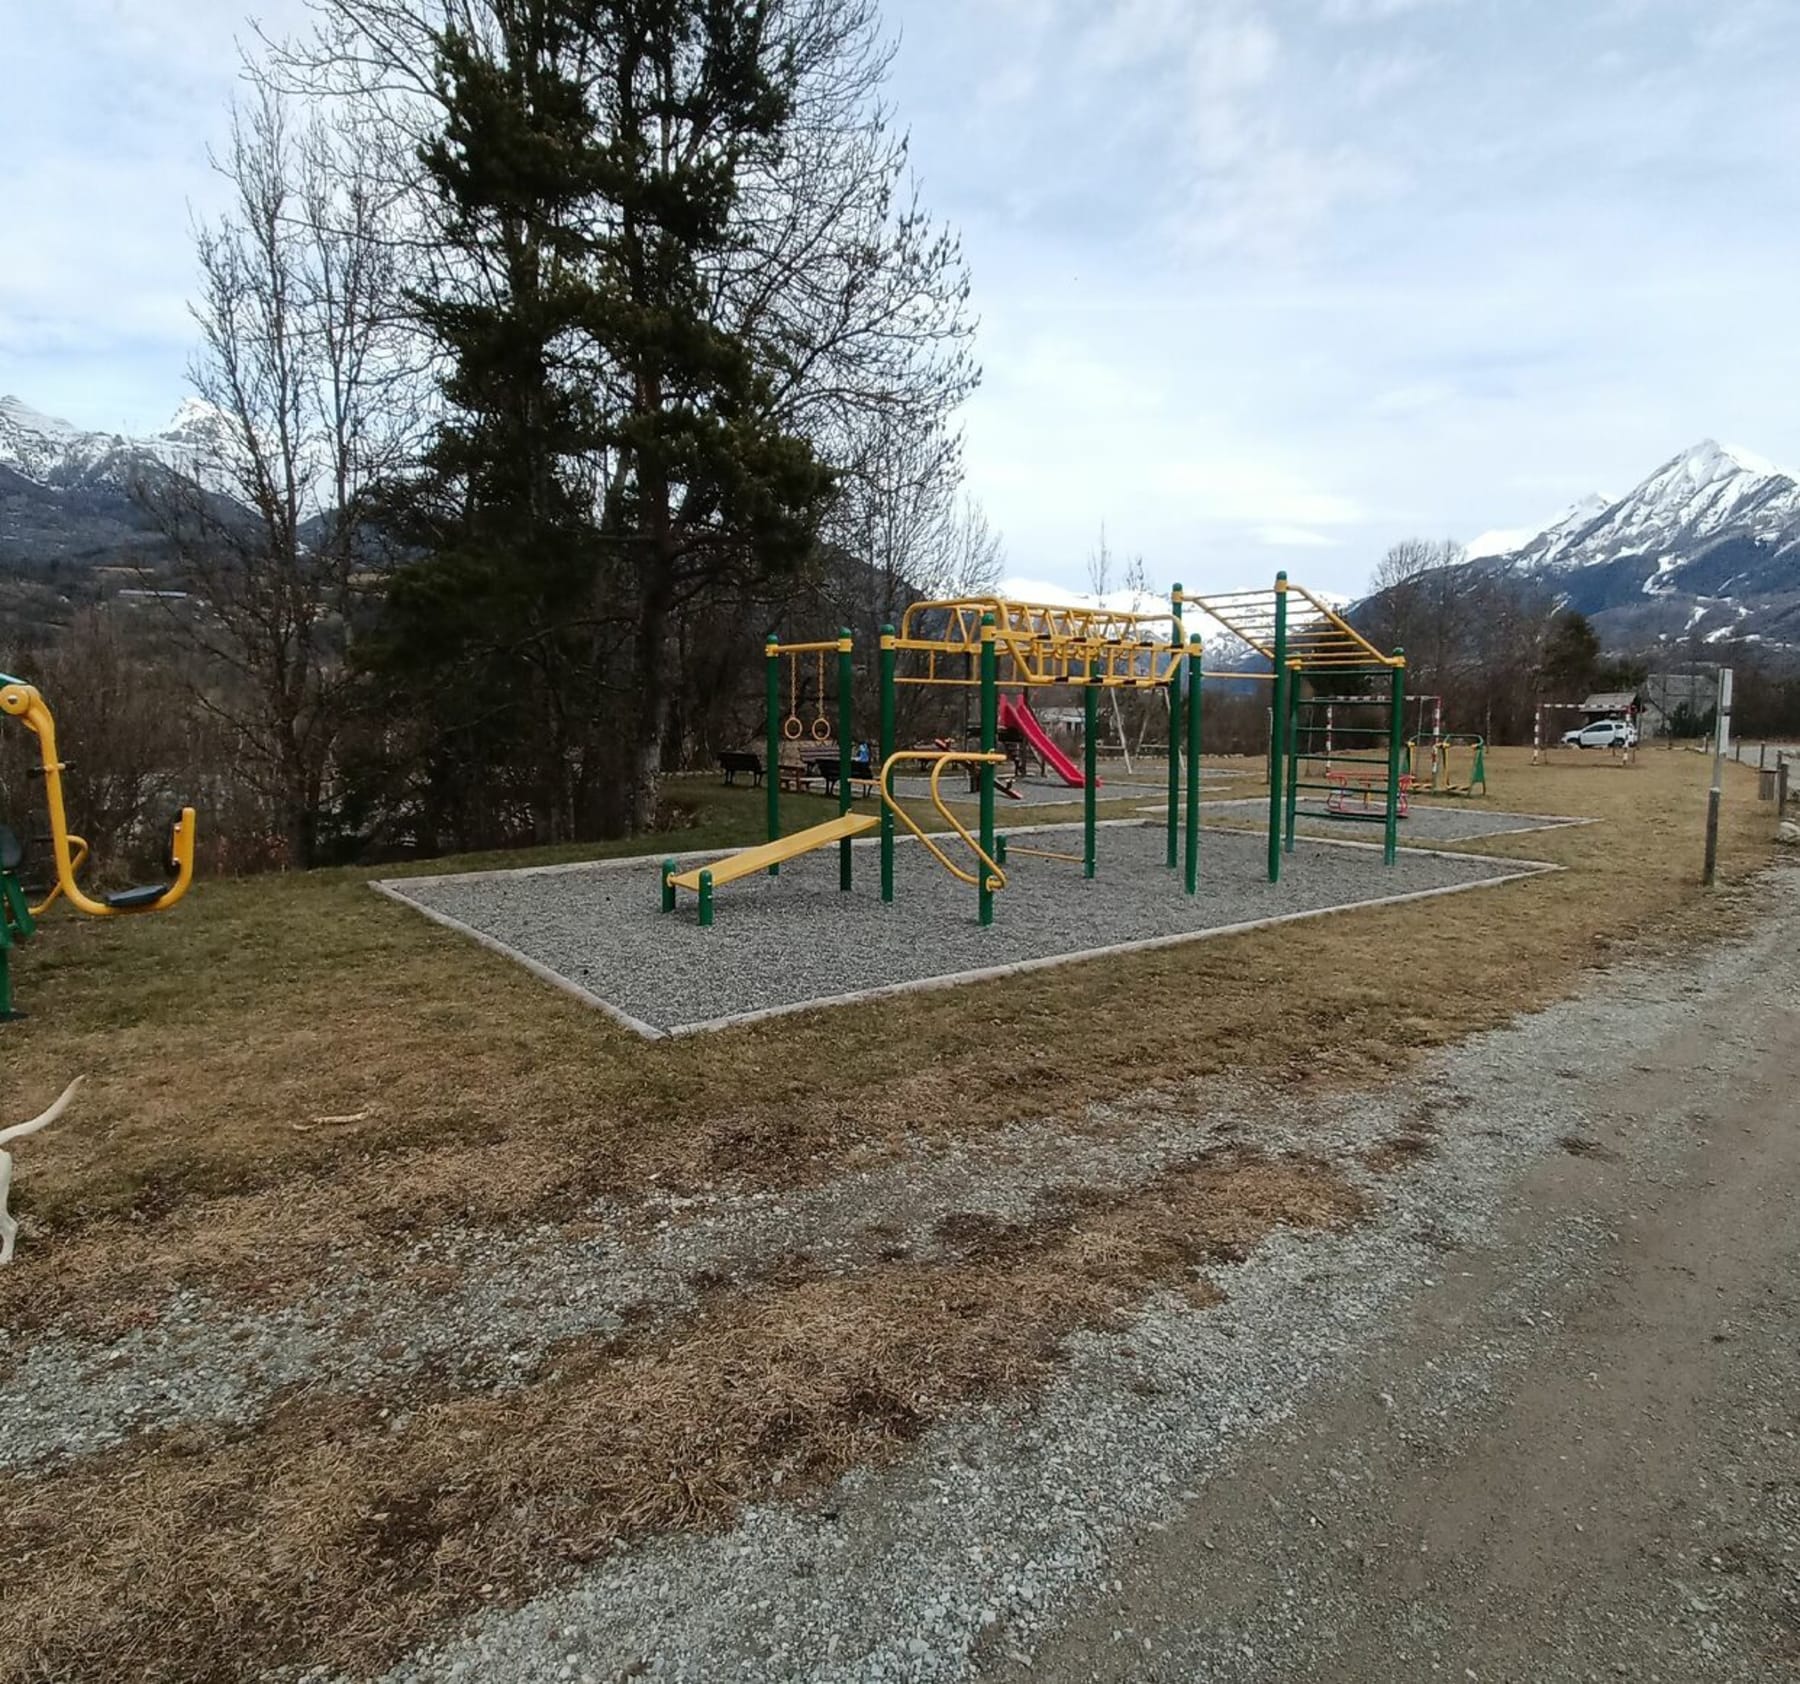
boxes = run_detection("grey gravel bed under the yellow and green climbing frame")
[387,824,1521,1031]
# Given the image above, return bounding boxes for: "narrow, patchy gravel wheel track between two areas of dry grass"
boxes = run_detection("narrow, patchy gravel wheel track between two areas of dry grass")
[0,1096,1238,1466]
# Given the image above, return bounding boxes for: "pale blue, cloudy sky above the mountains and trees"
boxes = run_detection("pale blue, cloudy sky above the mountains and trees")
[0,0,1800,590]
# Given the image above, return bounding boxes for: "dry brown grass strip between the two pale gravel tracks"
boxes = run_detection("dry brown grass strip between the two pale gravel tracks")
[0,1153,1361,1684]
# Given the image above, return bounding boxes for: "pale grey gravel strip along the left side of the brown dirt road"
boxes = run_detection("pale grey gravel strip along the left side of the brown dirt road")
[338,873,1800,1684]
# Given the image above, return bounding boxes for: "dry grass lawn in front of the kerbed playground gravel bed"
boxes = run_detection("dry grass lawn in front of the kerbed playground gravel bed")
[0,750,1771,1326]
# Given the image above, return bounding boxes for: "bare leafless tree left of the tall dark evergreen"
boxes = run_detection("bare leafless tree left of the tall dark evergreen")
[139,88,423,867]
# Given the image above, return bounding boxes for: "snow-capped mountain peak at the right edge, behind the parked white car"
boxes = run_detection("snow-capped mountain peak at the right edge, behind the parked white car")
[1471,439,1800,648]
